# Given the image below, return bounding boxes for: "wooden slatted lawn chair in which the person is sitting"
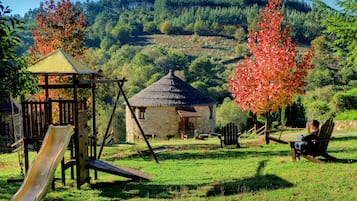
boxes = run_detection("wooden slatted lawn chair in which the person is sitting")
[289,118,337,163]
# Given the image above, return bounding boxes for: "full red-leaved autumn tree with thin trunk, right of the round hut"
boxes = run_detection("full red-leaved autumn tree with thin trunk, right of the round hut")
[228,0,313,143]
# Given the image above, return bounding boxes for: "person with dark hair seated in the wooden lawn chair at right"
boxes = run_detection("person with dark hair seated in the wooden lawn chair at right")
[294,120,320,153]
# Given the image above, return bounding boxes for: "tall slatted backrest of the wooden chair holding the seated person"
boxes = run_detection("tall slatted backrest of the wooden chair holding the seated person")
[315,118,335,152]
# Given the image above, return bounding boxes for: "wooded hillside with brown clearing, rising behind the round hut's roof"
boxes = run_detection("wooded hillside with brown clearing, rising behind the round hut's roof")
[16,0,324,107]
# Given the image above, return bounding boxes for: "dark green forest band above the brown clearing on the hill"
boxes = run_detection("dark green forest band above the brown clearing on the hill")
[20,0,323,51]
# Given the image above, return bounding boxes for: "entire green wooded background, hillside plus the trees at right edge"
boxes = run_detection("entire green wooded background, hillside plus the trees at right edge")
[3,0,357,140]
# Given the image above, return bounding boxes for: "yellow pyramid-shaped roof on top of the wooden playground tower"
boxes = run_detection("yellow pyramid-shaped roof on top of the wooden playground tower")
[28,50,97,75]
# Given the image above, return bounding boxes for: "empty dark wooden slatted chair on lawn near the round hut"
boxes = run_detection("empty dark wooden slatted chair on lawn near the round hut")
[213,122,241,148]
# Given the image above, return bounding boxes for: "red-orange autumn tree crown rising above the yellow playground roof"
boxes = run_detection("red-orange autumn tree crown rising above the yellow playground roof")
[31,0,87,58]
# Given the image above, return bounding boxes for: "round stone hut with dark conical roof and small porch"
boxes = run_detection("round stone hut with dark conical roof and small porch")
[126,71,216,142]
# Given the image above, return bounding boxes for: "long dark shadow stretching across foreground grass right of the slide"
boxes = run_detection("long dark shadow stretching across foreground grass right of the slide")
[91,161,294,200]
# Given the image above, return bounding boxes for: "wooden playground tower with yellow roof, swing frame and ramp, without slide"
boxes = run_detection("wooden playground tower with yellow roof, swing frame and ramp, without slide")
[9,50,158,196]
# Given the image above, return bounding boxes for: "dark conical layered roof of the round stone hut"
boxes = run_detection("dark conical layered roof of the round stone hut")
[129,71,216,107]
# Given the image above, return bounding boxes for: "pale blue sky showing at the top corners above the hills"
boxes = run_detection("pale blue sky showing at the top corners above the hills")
[0,0,336,16]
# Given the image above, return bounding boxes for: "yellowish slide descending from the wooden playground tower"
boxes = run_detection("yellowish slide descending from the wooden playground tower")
[11,125,73,201]
